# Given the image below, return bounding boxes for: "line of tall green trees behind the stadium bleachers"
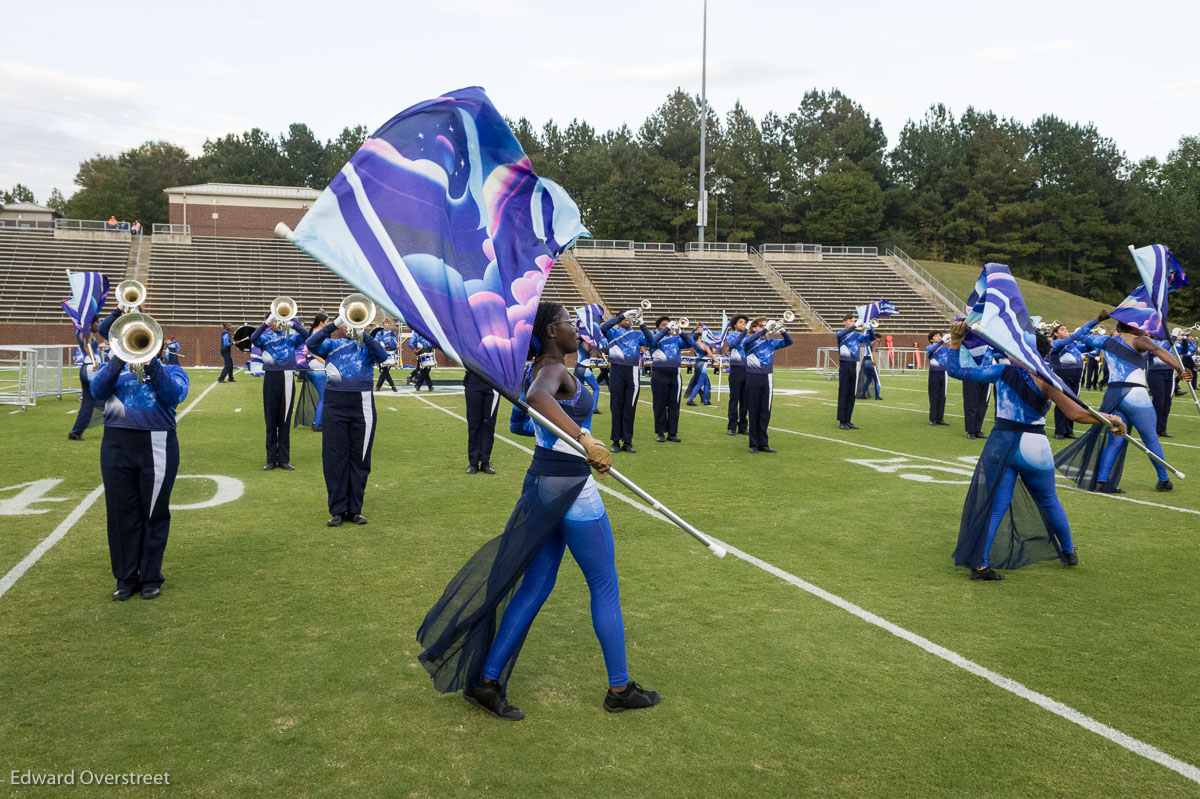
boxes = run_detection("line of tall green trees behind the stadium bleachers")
[6,89,1200,317]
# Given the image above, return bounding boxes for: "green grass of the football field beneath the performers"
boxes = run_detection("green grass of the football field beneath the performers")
[0,371,1200,798]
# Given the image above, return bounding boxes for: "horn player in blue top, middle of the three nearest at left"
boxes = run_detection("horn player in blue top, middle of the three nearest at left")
[250,314,308,471]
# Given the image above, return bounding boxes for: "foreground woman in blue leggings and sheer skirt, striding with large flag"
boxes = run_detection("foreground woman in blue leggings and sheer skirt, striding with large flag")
[416,302,659,721]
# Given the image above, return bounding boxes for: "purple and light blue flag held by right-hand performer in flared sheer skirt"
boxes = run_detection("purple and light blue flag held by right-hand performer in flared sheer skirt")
[966,264,1075,397]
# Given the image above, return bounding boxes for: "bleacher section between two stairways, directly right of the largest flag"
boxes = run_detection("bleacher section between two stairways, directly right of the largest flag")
[575,251,809,332]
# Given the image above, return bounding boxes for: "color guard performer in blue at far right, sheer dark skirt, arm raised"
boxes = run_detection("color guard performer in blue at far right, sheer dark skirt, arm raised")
[1057,311,1192,494]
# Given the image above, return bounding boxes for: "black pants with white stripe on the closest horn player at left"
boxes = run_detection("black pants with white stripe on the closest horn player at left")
[100,426,179,589]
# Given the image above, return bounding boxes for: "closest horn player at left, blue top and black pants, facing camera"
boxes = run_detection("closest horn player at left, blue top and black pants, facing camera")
[91,326,188,601]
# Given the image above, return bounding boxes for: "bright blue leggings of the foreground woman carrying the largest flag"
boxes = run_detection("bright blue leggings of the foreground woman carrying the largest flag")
[484,513,629,687]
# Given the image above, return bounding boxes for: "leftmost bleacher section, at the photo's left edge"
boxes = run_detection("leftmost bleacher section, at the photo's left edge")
[0,229,130,324]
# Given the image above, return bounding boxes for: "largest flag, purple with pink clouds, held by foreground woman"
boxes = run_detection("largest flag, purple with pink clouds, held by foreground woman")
[289,86,588,396]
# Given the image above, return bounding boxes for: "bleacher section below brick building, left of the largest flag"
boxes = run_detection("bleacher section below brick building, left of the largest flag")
[145,236,354,325]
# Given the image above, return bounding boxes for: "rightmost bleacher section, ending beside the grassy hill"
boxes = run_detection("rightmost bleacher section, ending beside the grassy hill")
[767,254,950,334]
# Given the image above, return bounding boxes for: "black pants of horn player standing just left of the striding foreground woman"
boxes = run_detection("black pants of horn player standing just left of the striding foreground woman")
[320,385,376,516]
